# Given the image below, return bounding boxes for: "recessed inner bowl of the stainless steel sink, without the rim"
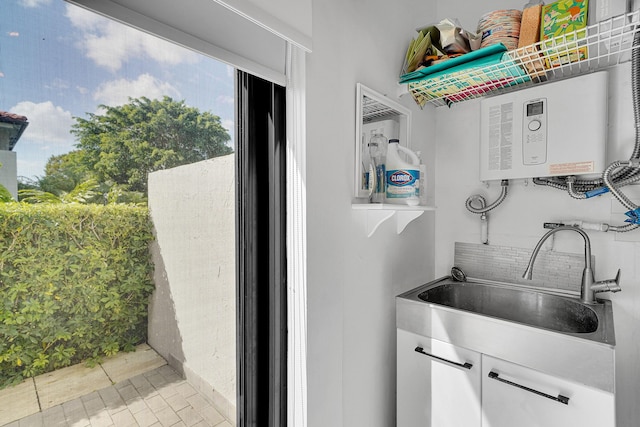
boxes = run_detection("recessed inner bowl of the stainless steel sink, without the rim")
[418,282,598,334]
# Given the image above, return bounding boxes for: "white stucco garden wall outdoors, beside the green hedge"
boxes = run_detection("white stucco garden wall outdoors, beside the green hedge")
[149,155,236,420]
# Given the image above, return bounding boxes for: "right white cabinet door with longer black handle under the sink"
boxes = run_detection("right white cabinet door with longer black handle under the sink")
[482,355,615,427]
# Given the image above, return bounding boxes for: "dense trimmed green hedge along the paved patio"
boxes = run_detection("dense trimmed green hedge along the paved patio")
[0,203,153,388]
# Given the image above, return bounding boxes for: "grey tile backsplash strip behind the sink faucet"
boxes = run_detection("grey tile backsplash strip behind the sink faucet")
[454,242,595,292]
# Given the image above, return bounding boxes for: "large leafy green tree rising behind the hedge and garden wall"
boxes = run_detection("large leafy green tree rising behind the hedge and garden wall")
[70,96,233,194]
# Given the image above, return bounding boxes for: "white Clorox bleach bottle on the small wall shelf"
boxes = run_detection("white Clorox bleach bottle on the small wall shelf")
[386,139,420,206]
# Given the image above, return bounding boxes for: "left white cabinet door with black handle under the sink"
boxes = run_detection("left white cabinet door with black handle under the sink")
[397,329,481,427]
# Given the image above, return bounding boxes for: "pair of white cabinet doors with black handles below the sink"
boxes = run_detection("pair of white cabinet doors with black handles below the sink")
[397,329,615,427]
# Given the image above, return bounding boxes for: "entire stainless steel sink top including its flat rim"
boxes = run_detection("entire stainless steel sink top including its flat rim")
[398,276,615,346]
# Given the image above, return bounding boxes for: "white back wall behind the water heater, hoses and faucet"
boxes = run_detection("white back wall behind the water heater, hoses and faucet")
[430,0,640,427]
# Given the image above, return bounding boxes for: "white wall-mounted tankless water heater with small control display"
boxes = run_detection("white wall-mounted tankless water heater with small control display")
[480,71,607,181]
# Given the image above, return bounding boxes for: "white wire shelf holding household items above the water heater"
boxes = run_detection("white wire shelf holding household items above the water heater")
[408,9,640,107]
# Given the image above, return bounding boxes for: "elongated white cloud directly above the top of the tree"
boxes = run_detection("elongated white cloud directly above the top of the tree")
[93,74,180,107]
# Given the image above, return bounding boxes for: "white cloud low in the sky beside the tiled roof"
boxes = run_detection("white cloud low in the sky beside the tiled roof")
[9,101,74,150]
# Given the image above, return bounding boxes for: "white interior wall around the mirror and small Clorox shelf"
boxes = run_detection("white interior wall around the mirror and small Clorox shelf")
[306,0,435,427]
